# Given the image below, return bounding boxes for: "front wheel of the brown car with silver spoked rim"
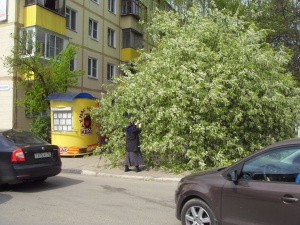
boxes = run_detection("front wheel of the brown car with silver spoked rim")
[181,199,215,225]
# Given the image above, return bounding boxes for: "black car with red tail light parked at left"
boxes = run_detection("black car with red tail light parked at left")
[0,129,62,185]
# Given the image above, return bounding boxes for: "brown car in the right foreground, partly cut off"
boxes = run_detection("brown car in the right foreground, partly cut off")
[175,139,300,225]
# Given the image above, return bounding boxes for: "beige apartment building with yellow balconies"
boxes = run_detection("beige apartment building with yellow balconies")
[0,0,166,129]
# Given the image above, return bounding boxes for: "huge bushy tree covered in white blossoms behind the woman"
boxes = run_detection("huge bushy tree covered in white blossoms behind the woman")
[92,7,299,172]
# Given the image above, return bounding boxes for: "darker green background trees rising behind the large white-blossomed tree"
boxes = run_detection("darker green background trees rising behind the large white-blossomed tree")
[171,0,300,81]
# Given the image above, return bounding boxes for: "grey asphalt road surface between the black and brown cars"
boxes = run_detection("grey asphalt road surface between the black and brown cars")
[0,173,181,225]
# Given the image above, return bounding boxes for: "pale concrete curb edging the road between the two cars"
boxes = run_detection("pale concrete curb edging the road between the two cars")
[61,169,181,182]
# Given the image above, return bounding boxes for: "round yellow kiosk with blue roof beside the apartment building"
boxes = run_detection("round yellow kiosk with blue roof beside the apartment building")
[46,93,98,156]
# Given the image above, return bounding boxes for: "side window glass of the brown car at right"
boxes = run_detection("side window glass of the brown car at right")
[241,147,300,183]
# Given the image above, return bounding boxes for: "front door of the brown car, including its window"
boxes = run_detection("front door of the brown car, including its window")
[221,147,300,225]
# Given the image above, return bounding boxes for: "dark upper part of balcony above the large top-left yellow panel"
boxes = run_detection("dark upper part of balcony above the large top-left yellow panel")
[25,0,66,16]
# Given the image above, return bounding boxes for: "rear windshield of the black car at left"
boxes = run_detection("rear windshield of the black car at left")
[2,130,47,145]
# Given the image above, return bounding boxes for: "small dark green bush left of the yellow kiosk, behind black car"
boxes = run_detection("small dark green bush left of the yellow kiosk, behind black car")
[30,116,51,143]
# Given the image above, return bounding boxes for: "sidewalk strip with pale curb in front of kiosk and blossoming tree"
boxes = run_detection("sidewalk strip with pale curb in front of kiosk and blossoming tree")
[61,155,190,182]
